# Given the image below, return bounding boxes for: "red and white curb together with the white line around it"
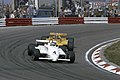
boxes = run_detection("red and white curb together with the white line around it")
[85,38,120,75]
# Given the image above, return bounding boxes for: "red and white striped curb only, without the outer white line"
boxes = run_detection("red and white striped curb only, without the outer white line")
[92,44,120,75]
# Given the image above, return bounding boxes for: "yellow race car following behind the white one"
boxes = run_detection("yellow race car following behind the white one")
[41,33,74,51]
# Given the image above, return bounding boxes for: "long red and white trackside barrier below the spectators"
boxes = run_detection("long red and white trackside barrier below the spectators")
[0,17,120,27]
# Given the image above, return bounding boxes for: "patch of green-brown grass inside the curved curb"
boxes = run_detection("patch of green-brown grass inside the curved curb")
[104,41,120,66]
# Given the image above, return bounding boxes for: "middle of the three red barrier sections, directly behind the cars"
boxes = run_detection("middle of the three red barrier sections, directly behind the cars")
[58,17,84,24]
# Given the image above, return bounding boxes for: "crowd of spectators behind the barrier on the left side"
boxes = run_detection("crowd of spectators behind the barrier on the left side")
[3,7,37,18]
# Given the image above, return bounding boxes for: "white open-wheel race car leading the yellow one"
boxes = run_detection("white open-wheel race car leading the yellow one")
[28,40,75,63]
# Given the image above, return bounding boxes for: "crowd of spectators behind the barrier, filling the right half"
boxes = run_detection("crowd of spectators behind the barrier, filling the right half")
[59,2,120,17]
